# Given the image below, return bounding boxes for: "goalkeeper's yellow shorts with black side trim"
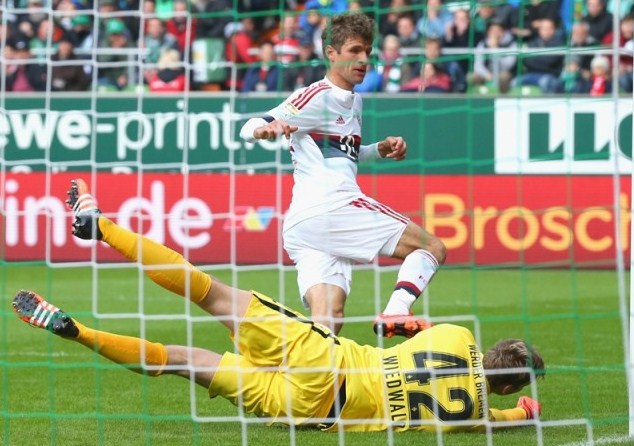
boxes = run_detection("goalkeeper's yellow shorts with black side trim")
[209,291,344,424]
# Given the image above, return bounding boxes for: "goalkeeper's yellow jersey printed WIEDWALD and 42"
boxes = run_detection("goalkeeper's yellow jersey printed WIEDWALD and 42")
[327,324,488,431]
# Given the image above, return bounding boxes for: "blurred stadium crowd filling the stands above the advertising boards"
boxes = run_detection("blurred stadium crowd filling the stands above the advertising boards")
[0,0,634,96]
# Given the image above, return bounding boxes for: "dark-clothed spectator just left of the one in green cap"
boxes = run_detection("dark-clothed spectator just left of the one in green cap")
[51,34,92,91]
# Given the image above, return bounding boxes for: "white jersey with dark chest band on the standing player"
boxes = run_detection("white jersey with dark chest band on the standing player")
[265,78,378,230]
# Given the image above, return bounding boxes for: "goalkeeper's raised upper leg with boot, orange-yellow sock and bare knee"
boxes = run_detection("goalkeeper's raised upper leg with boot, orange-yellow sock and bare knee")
[67,179,251,330]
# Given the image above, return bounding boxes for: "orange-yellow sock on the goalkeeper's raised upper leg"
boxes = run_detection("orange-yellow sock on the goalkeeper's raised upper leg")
[99,216,211,303]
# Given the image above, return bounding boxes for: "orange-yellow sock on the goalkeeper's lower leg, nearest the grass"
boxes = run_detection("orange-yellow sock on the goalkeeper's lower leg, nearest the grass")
[73,320,167,376]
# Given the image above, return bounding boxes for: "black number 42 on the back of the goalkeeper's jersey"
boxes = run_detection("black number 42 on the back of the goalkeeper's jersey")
[405,352,474,421]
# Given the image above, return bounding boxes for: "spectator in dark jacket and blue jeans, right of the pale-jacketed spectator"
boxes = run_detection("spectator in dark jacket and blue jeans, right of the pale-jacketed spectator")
[514,19,565,93]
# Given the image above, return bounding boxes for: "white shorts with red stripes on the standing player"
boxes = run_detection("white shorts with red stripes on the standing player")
[284,197,409,306]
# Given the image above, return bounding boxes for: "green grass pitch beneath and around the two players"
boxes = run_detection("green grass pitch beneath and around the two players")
[0,264,634,446]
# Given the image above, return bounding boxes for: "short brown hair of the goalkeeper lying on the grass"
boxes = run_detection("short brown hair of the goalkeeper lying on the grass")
[482,339,546,389]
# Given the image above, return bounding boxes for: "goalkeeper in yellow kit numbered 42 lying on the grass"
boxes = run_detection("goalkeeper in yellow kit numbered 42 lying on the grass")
[13,180,544,431]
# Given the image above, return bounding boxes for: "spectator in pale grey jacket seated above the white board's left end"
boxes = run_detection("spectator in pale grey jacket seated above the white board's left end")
[471,20,517,93]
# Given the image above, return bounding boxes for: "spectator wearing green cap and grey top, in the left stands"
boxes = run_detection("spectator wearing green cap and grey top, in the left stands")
[97,19,135,90]
